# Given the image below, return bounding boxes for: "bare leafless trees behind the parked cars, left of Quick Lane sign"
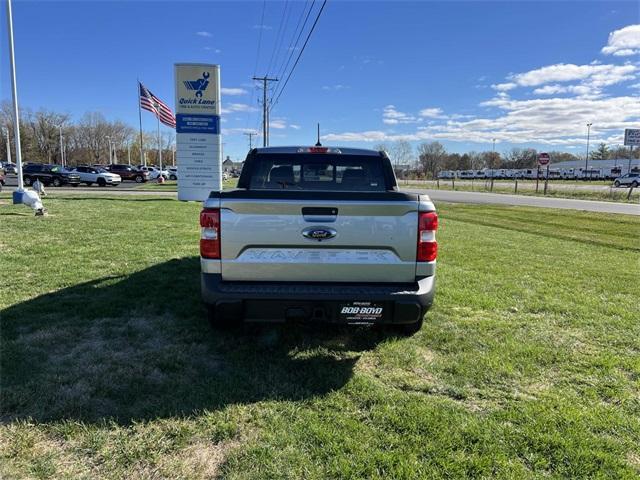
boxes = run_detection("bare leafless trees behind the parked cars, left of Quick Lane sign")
[0,102,175,165]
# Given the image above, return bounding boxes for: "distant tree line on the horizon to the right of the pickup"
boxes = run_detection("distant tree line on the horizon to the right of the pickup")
[374,140,640,178]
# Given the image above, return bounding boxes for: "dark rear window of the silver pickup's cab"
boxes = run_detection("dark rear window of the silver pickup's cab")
[238,153,390,192]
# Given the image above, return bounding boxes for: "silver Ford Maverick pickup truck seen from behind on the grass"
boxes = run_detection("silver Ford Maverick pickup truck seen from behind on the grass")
[200,146,438,334]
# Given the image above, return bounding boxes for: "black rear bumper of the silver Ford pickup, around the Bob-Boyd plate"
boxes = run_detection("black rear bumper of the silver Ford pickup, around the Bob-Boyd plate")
[201,273,435,324]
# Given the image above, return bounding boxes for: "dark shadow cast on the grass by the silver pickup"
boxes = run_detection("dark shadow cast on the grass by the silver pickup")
[0,258,384,424]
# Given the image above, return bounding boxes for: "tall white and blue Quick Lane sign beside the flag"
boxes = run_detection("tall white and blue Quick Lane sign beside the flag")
[175,63,222,201]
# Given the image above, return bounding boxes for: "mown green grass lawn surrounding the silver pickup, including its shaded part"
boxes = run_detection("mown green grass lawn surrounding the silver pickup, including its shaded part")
[0,195,640,479]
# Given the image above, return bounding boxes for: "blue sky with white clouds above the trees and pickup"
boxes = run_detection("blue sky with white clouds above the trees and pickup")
[0,0,640,158]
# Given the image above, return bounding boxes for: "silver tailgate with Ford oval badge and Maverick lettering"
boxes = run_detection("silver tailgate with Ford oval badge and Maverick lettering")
[219,194,418,282]
